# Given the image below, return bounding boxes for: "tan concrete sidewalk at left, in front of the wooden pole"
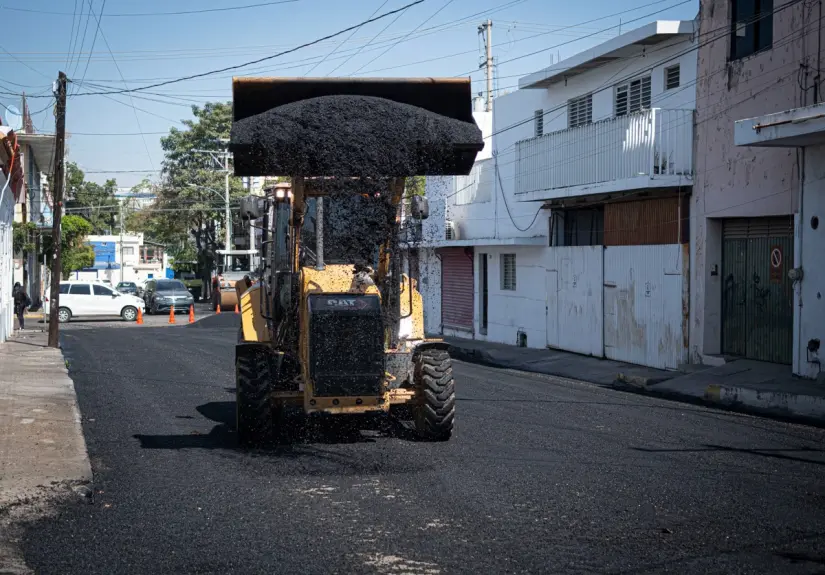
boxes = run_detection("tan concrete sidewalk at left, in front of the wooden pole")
[0,324,92,510]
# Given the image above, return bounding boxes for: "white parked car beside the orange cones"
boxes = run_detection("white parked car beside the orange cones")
[43,281,146,323]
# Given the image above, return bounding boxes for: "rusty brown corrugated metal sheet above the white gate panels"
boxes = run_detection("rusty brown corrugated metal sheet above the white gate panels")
[604,195,690,246]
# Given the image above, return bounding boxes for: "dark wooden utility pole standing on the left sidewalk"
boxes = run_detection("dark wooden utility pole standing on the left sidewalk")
[49,72,68,347]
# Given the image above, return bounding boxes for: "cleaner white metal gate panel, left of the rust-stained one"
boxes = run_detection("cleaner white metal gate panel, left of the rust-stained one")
[545,246,604,357]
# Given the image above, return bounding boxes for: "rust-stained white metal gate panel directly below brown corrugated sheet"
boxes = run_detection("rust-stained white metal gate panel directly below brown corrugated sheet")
[604,244,687,369]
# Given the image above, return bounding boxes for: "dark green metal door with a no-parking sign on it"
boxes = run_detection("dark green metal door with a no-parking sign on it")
[722,217,793,364]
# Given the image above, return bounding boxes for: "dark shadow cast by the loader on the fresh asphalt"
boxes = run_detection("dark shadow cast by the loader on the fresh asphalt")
[134,400,418,455]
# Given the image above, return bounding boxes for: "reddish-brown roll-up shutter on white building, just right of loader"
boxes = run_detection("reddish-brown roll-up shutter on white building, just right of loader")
[438,248,473,332]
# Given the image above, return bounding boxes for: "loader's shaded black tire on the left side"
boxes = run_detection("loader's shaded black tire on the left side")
[235,350,275,445]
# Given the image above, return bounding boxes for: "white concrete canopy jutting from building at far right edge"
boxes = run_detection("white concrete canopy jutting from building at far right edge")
[733,104,825,148]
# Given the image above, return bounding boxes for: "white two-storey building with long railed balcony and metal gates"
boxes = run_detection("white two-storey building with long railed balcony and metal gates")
[420,21,696,369]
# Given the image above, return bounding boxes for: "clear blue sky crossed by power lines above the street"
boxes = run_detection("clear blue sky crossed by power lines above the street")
[0,0,698,186]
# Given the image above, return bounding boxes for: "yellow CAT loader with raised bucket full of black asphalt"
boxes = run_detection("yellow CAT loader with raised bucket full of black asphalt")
[229,78,484,444]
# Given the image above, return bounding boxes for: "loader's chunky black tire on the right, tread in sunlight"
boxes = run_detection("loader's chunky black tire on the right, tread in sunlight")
[413,349,455,441]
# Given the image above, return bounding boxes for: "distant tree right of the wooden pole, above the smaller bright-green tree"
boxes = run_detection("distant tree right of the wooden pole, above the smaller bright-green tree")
[66,162,119,234]
